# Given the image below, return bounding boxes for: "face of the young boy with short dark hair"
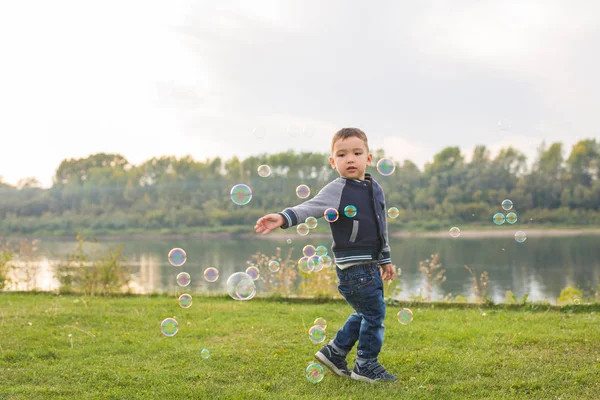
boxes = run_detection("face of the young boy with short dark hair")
[329,136,373,179]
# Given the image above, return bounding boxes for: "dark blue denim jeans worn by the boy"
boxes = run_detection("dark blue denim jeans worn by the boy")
[333,262,385,360]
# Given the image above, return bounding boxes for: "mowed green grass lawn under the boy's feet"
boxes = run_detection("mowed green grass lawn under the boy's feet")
[0,293,600,399]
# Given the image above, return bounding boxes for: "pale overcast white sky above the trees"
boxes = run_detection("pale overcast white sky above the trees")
[0,0,600,186]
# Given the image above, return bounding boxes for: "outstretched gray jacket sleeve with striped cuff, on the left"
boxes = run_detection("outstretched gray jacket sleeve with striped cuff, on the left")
[279,178,345,229]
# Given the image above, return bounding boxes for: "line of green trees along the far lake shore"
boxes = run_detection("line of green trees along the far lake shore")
[0,139,600,234]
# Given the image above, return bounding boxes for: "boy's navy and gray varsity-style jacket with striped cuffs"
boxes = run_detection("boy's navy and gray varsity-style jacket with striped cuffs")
[279,174,392,265]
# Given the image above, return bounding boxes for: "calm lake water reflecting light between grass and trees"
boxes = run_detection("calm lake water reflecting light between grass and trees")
[5,234,600,303]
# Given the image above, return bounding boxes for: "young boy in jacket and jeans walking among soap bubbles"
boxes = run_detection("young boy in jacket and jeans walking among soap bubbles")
[254,128,398,382]
